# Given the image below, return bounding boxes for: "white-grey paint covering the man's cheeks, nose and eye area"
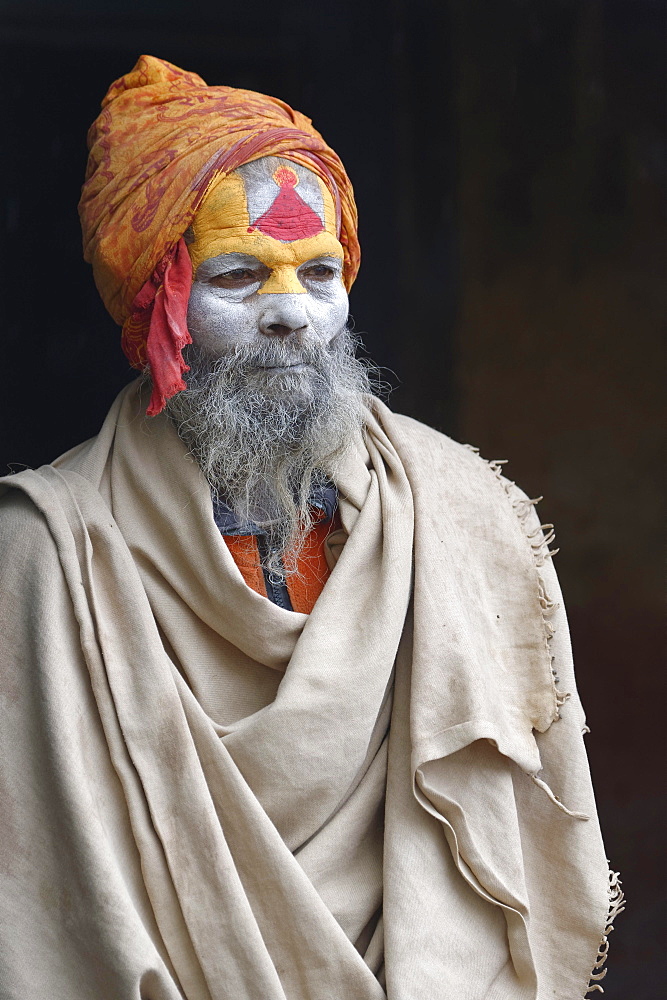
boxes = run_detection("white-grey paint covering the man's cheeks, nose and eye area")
[188,253,349,357]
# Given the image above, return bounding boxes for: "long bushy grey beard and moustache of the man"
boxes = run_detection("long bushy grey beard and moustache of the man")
[166,328,373,579]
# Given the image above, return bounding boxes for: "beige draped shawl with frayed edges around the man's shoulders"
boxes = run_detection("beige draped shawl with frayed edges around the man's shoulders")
[0,383,608,1000]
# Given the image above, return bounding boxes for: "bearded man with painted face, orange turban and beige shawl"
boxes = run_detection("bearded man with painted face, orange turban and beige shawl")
[0,56,621,1000]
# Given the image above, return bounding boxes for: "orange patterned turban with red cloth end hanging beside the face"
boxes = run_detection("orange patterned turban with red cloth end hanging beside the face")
[79,56,359,413]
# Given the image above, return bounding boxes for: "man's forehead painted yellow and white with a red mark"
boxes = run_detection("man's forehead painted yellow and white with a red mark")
[189,156,343,270]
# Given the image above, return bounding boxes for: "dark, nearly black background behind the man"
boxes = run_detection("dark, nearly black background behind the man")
[0,0,666,1000]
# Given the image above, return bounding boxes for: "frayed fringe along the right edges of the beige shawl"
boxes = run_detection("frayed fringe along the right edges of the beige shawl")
[465,444,625,1000]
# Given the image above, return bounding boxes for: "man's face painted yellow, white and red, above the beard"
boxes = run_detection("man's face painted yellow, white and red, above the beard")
[188,156,348,356]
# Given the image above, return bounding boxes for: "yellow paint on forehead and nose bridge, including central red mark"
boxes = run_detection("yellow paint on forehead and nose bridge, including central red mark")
[188,163,343,295]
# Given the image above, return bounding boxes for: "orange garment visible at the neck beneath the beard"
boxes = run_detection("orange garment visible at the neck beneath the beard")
[223,511,341,615]
